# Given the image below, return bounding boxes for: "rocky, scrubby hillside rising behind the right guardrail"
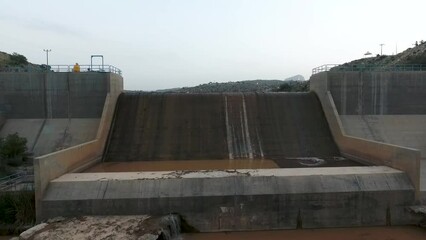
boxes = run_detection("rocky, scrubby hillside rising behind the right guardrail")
[335,42,426,70]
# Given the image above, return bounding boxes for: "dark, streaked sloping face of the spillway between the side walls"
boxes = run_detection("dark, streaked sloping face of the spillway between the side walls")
[104,92,359,167]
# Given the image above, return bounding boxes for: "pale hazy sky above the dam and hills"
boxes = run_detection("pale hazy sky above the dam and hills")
[0,0,426,90]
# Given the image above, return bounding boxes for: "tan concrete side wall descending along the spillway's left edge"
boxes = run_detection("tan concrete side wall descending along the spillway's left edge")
[34,74,123,221]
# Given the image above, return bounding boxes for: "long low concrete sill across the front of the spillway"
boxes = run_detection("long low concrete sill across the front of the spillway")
[41,166,418,232]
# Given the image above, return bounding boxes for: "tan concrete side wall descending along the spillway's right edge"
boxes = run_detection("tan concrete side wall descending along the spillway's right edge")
[310,72,420,197]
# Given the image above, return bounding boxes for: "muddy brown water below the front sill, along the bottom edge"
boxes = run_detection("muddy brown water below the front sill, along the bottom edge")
[182,226,426,240]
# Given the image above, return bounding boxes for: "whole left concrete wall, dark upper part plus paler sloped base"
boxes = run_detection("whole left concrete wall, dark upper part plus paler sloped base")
[0,72,118,157]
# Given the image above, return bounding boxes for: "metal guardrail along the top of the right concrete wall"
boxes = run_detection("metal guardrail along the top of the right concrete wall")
[312,64,426,75]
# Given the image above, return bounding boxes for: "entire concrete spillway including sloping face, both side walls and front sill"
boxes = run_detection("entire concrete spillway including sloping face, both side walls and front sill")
[34,73,418,232]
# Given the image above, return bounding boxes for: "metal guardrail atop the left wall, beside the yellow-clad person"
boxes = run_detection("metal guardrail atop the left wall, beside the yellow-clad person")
[0,64,122,75]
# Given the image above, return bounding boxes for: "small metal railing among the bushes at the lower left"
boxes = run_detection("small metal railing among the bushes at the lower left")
[0,172,34,192]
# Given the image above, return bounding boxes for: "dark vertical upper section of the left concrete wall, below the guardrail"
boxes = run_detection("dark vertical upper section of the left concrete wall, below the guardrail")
[0,72,109,119]
